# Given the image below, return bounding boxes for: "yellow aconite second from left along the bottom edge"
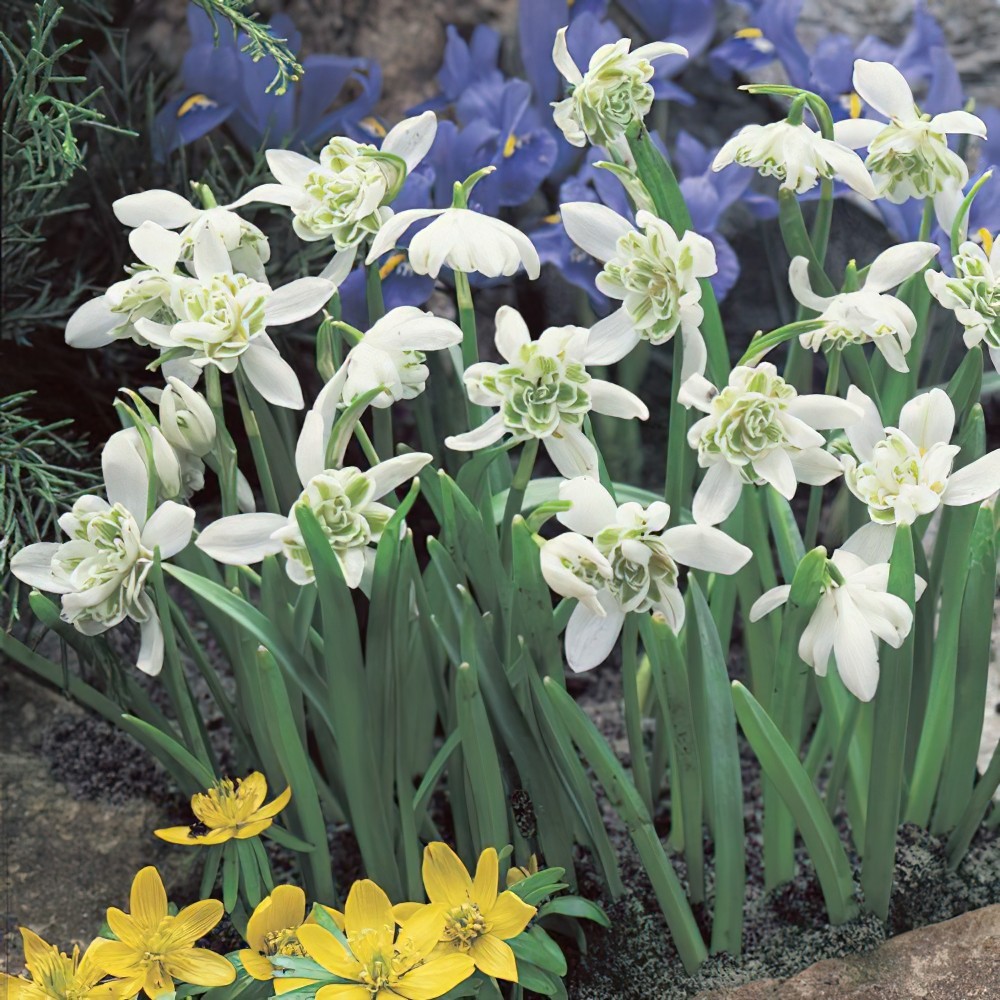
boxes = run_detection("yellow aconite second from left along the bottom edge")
[97,866,236,1000]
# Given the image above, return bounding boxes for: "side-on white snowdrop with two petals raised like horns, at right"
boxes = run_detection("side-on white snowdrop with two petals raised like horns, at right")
[788,243,940,372]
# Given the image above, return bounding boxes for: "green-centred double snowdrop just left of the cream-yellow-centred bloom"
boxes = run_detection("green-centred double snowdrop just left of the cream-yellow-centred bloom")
[678,362,862,524]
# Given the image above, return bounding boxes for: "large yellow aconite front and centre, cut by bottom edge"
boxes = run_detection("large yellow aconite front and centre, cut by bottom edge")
[299,879,475,1000]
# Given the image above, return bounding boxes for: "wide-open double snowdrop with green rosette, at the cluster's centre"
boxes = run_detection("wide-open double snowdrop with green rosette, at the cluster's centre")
[444,306,649,478]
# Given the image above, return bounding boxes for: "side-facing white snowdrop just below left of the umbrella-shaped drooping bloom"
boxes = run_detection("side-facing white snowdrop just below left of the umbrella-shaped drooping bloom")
[314,306,462,410]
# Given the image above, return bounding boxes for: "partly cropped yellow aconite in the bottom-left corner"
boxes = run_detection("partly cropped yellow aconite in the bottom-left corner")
[0,927,124,1000]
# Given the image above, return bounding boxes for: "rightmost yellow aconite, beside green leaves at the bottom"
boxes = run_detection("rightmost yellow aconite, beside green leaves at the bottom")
[395,843,536,983]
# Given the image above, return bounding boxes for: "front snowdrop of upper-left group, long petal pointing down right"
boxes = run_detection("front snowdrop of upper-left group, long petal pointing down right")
[135,231,335,409]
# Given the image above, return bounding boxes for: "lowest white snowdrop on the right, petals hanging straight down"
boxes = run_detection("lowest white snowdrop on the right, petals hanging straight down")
[750,549,923,701]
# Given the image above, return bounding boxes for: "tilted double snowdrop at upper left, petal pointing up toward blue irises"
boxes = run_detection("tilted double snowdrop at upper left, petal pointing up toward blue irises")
[235,111,437,257]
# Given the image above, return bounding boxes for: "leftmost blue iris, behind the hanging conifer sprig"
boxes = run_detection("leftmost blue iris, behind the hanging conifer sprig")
[153,4,382,161]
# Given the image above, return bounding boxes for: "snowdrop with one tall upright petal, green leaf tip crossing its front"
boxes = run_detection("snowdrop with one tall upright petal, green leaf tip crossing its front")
[195,408,432,587]
